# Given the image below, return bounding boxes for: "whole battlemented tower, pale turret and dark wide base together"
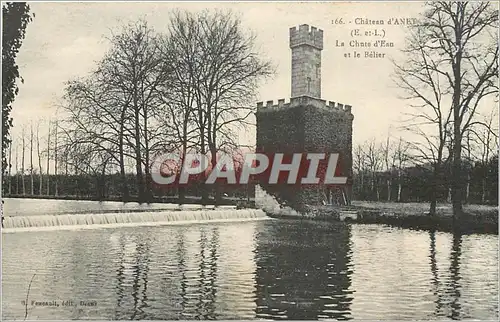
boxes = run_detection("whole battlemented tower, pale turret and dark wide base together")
[255,25,354,209]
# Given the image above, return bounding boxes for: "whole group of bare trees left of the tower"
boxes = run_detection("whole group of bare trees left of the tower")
[4,10,274,202]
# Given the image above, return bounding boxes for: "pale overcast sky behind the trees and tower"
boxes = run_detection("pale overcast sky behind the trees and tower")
[12,2,442,148]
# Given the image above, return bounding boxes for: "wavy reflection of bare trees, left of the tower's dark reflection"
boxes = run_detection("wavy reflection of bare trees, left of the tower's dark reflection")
[114,227,224,320]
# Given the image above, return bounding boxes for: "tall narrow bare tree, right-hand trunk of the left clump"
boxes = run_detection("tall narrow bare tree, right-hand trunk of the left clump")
[101,21,172,202]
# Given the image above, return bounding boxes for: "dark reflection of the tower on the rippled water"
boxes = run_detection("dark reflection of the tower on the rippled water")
[256,223,353,320]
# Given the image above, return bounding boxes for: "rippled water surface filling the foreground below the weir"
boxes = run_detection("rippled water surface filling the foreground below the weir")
[2,221,498,320]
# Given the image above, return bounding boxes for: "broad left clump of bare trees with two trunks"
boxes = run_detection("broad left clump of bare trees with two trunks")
[59,20,172,202]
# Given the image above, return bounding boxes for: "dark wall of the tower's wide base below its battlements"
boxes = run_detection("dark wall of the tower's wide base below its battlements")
[256,105,353,210]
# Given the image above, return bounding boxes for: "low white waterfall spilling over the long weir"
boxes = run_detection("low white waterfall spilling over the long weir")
[2,207,268,232]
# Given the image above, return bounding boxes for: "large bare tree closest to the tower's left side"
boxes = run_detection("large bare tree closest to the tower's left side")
[165,11,273,202]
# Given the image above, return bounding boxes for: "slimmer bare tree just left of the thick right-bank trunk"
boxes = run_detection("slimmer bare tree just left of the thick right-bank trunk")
[393,19,451,215]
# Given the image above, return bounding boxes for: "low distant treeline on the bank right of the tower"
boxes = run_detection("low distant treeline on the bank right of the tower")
[353,139,498,205]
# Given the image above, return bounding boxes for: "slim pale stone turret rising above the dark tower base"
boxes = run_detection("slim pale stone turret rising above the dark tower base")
[290,25,323,98]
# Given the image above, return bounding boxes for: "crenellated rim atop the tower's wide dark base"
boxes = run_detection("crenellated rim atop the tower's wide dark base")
[257,96,352,114]
